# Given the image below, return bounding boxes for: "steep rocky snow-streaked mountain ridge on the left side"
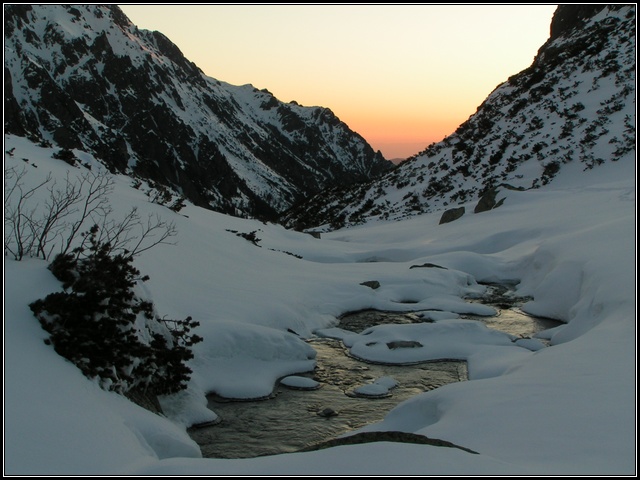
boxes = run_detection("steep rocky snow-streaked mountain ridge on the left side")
[4,4,393,218]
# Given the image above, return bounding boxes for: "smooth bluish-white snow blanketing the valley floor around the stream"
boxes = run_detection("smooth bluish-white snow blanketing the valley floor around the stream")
[4,118,636,475]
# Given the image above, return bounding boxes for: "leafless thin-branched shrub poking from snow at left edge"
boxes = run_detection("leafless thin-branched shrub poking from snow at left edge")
[4,167,176,260]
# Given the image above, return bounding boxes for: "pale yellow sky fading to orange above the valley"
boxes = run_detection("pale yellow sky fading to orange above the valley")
[120,4,556,159]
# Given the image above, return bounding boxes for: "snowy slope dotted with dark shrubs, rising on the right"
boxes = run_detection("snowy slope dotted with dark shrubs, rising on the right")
[282,5,636,230]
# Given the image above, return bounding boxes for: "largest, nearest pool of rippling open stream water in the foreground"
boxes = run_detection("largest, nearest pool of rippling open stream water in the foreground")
[189,338,467,458]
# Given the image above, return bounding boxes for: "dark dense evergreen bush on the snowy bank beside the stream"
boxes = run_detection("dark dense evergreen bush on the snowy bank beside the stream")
[30,226,202,395]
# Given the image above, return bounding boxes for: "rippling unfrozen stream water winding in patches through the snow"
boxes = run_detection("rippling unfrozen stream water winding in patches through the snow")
[188,286,559,458]
